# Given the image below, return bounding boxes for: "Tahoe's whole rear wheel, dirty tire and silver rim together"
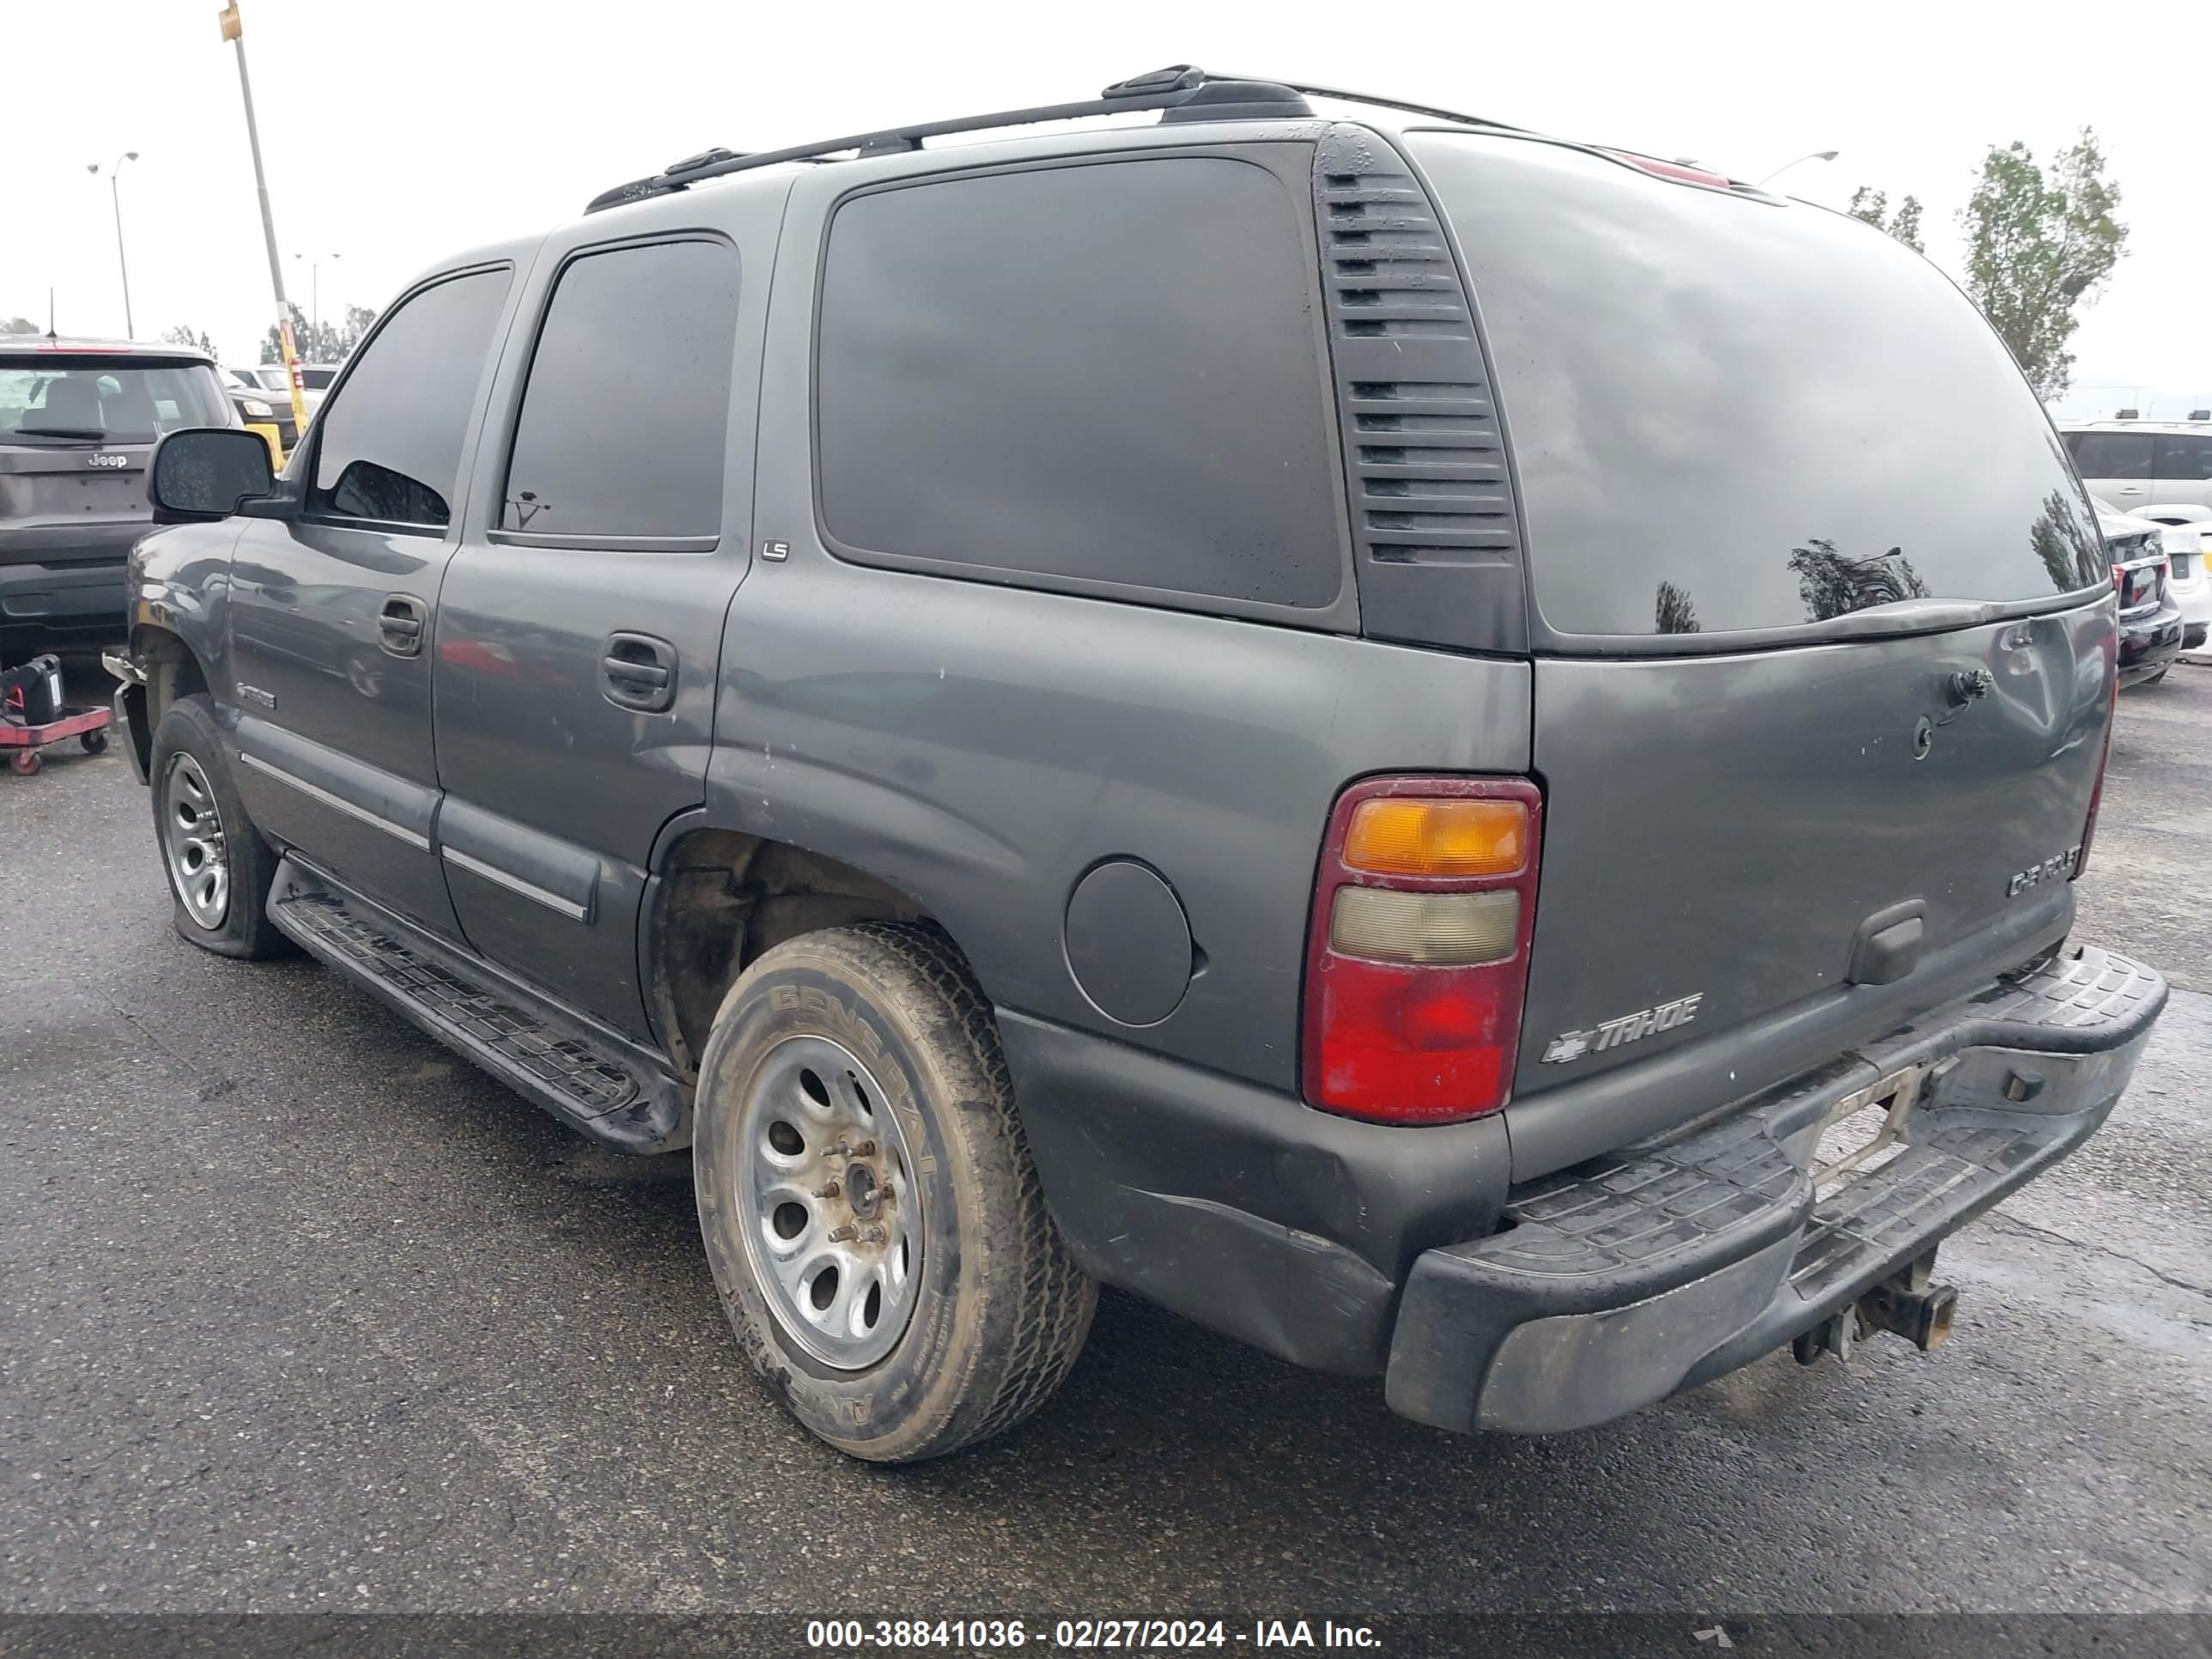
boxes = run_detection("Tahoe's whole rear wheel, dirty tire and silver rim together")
[692,922,1097,1462]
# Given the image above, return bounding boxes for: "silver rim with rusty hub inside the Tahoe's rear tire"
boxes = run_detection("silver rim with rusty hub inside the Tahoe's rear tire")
[737,1037,922,1371]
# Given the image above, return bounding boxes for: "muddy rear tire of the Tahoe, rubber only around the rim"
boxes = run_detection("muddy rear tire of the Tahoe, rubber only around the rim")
[692,922,1097,1462]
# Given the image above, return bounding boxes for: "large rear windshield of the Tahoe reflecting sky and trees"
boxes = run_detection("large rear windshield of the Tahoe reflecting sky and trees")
[1407,133,2108,635]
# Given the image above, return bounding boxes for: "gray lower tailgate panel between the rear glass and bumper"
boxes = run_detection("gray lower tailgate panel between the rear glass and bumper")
[1510,602,2112,1175]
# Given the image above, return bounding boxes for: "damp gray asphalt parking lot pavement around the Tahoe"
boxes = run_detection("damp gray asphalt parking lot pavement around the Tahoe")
[0,668,2212,1617]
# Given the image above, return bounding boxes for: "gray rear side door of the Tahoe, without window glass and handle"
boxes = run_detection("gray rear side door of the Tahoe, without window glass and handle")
[435,179,787,1037]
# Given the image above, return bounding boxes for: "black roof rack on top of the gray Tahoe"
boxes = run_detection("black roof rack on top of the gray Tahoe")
[584,64,1520,212]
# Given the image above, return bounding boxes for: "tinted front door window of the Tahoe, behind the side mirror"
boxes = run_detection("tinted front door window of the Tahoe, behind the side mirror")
[312,270,507,526]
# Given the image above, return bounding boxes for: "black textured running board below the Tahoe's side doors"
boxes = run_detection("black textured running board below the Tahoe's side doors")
[268,854,690,1157]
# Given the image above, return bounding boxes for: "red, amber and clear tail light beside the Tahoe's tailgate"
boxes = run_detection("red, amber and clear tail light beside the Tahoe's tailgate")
[1305,779,1544,1124]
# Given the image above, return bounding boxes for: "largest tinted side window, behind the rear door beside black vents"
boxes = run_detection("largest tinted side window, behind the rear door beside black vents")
[817,157,1340,606]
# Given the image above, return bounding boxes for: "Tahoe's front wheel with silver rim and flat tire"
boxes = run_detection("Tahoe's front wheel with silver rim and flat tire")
[149,696,289,957]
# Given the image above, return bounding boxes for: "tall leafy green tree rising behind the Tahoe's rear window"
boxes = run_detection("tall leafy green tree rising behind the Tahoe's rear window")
[1958,126,2128,398]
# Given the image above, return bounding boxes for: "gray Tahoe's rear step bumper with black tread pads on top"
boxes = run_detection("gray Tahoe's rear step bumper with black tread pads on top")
[1387,947,2166,1433]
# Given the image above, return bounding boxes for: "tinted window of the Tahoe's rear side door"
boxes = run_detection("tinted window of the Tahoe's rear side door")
[500,241,737,538]
